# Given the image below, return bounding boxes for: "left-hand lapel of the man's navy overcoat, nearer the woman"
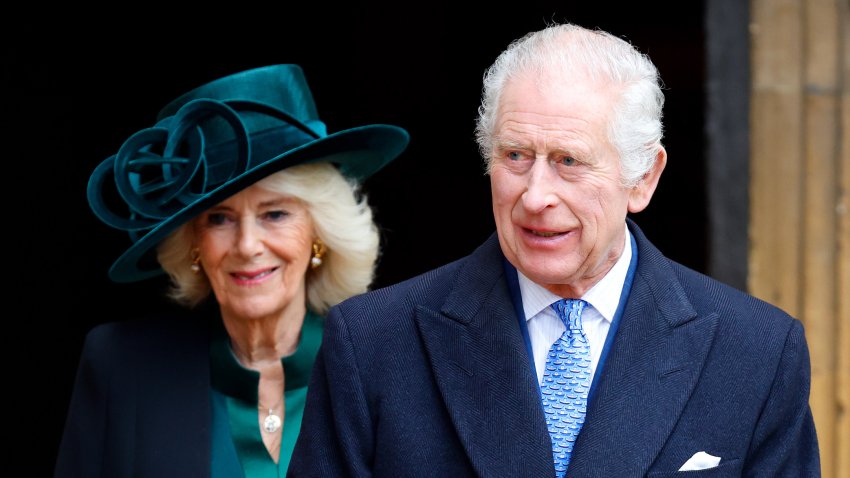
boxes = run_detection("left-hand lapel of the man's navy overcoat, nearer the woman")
[416,235,554,476]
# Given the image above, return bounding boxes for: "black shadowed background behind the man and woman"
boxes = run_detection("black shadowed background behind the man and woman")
[2,1,707,476]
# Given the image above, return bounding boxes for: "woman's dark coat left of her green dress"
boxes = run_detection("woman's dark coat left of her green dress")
[55,311,212,478]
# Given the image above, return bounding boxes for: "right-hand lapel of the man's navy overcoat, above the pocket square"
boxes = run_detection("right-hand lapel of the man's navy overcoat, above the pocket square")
[568,224,718,477]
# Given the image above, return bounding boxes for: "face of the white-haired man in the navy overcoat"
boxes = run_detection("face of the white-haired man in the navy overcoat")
[490,75,654,297]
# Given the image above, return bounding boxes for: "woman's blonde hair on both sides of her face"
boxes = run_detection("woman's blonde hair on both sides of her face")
[157,162,379,315]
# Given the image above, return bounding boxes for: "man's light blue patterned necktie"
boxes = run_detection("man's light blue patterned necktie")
[540,299,590,478]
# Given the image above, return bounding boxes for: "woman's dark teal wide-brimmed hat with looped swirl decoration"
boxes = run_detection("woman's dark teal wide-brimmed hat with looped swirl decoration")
[87,65,409,282]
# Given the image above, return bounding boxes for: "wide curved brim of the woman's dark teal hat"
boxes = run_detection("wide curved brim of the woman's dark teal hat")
[104,125,409,282]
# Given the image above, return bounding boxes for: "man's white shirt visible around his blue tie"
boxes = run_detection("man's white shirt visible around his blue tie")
[517,228,632,383]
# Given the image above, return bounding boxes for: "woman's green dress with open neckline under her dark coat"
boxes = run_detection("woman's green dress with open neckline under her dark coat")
[210,311,324,478]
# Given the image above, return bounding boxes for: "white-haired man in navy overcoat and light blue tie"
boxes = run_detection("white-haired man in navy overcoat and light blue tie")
[290,25,820,478]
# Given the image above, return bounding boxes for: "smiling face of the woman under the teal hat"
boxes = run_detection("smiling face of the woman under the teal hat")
[194,185,316,320]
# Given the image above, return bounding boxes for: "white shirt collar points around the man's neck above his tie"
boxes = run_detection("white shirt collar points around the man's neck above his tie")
[517,223,632,322]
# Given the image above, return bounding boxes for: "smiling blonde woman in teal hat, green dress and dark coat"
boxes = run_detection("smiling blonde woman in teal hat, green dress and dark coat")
[56,65,408,478]
